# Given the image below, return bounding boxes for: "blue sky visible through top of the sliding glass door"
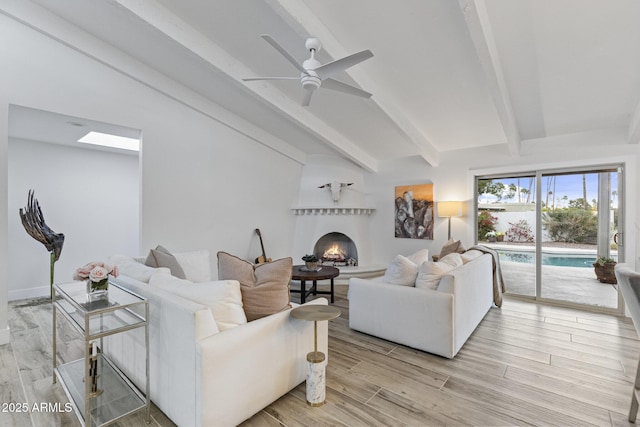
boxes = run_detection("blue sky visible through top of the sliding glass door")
[478,173,618,207]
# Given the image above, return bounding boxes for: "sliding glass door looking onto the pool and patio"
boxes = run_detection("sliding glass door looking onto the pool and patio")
[476,165,624,311]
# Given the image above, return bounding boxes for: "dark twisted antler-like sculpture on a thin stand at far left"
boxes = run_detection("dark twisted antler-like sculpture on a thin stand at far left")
[20,190,64,301]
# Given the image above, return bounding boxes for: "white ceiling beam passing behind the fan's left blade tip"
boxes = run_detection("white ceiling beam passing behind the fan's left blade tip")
[115,0,378,172]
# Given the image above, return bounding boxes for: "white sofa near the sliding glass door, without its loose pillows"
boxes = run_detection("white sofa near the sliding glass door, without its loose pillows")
[349,253,493,358]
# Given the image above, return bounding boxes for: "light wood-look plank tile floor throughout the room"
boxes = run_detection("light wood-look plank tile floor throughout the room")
[0,286,640,427]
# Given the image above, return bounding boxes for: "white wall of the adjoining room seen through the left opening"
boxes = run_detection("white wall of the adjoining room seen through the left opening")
[8,139,140,301]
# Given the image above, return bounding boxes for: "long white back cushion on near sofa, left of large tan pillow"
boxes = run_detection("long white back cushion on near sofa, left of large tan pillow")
[149,274,247,331]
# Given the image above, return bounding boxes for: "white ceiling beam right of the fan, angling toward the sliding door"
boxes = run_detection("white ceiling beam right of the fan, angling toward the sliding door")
[458,0,520,156]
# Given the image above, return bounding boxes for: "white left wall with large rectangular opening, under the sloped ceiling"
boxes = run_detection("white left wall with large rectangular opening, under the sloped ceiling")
[0,10,302,344]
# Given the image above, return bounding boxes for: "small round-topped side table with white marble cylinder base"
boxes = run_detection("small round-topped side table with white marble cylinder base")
[291,305,341,406]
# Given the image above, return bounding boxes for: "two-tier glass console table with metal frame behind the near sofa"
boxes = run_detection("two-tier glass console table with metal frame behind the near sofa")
[53,282,150,427]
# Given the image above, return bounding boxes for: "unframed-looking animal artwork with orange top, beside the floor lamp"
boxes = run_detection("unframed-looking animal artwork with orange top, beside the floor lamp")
[395,184,434,240]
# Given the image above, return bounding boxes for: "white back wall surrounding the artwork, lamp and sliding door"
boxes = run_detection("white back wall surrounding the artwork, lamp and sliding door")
[365,140,640,264]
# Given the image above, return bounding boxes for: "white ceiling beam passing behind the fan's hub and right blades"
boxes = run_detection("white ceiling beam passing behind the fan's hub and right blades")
[265,0,440,166]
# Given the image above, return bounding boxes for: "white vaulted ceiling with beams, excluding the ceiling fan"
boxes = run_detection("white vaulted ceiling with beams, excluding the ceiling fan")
[11,0,640,171]
